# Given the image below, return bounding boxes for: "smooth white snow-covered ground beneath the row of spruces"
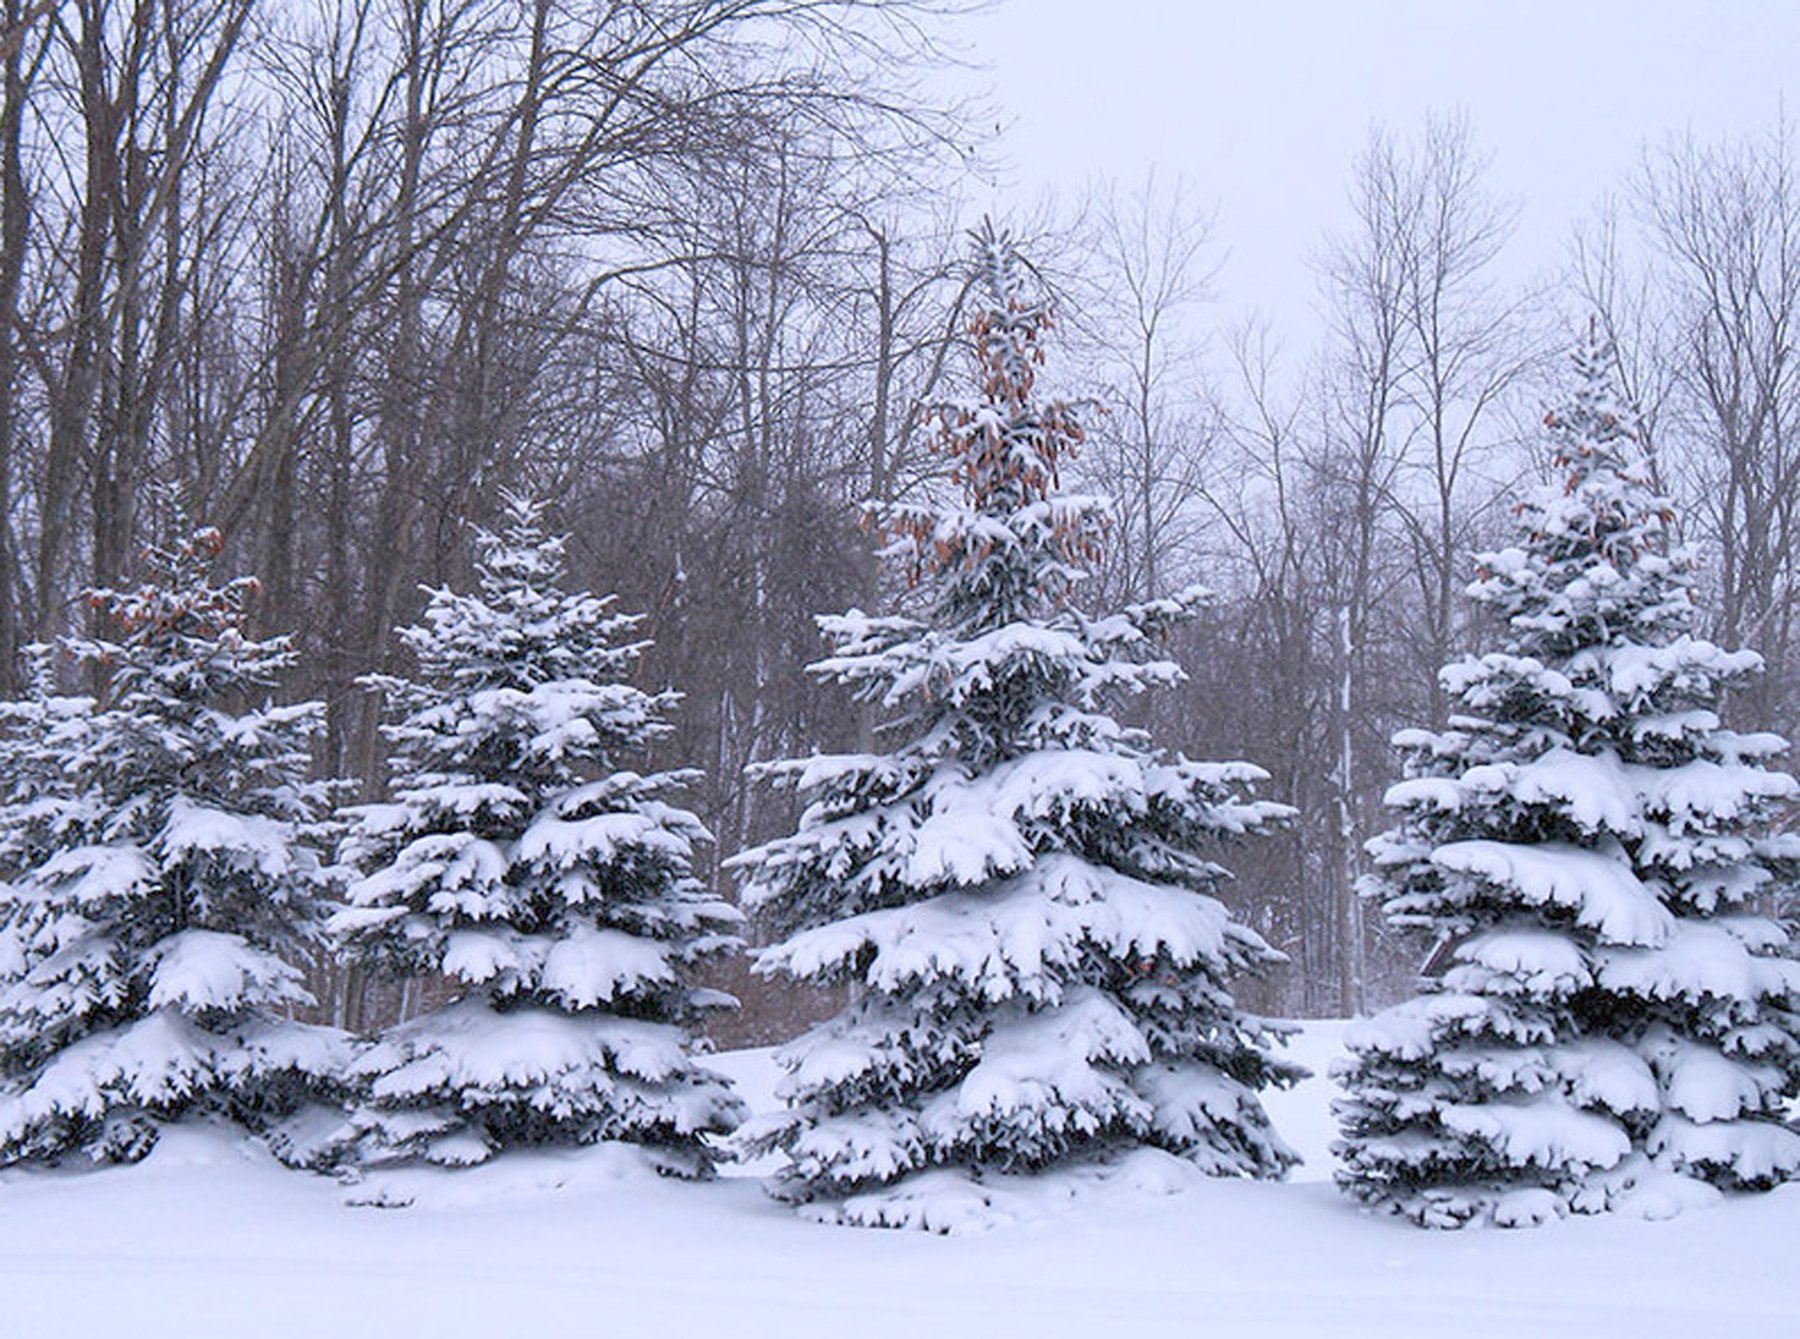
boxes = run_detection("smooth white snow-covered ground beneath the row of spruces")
[0,1024,1800,1339]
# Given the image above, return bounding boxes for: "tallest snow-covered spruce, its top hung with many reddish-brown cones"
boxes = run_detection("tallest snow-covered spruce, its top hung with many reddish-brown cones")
[734,229,1301,1231]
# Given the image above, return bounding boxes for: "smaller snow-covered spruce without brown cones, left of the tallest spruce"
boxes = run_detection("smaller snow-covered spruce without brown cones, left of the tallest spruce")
[333,499,740,1175]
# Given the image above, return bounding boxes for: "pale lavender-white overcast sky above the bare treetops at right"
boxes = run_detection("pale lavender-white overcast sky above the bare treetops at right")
[968,0,1800,331]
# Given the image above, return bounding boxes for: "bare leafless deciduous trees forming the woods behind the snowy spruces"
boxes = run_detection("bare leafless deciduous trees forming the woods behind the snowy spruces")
[0,0,1800,1035]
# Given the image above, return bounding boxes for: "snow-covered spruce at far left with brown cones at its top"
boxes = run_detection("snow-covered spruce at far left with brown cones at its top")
[0,529,347,1163]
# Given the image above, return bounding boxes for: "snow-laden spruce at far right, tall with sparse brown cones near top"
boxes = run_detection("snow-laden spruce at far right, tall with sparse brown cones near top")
[1336,335,1800,1227]
